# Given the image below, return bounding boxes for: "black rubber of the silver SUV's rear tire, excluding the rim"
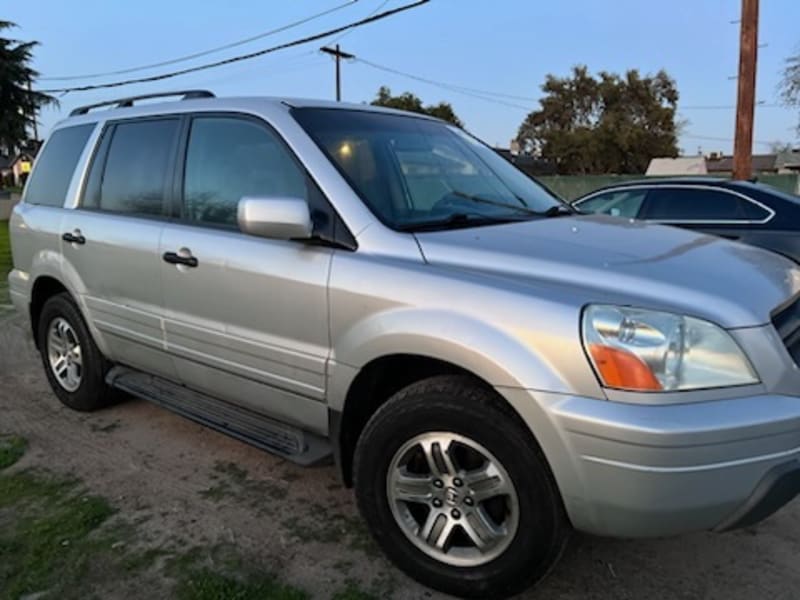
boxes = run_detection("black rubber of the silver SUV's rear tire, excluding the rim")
[37,294,109,411]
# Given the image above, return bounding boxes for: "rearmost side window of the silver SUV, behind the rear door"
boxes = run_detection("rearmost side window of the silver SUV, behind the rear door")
[25,123,95,206]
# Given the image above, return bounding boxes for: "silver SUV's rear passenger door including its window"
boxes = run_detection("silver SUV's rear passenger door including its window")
[62,117,180,379]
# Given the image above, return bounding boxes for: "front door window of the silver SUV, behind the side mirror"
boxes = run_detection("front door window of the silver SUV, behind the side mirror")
[183,117,308,226]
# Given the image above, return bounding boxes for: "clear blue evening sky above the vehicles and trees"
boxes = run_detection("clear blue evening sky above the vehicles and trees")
[2,0,800,154]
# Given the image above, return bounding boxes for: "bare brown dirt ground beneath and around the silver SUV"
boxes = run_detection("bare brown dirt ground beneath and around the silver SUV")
[0,316,800,600]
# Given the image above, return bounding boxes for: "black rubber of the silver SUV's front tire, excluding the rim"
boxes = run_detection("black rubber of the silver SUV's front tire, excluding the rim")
[354,381,568,598]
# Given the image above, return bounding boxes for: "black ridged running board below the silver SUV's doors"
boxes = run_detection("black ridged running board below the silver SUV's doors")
[106,366,332,466]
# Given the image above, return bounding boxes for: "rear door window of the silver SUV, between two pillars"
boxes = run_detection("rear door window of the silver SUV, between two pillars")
[83,119,179,215]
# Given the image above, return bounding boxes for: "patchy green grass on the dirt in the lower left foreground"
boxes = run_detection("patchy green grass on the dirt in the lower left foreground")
[0,435,314,600]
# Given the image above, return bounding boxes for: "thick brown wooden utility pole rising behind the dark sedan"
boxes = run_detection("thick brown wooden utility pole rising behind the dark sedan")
[733,0,758,179]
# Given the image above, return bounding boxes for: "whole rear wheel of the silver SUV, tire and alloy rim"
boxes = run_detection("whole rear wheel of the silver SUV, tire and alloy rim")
[37,293,116,412]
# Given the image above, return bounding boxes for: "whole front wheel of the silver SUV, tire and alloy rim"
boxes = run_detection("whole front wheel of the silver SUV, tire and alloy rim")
[353,376,570,598]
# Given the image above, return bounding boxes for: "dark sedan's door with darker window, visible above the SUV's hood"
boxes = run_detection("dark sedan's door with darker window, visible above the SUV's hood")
[642,186,770,240]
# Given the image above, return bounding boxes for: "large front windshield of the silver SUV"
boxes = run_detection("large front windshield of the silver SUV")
[293,108,570,231]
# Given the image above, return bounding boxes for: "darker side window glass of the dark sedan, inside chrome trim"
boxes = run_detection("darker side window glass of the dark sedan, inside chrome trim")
[645,187,749,221]
